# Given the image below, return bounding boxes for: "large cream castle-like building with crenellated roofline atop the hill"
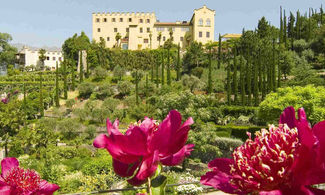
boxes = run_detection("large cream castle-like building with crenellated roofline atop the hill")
[92,6,215,50]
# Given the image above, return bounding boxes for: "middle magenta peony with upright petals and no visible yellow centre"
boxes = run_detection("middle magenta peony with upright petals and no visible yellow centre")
[94,110,194,185]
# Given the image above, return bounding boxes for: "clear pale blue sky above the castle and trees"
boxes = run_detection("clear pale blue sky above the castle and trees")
[0,0,325,47]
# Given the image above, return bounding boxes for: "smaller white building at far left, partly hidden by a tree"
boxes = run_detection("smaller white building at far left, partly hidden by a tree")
[16,46,63,70]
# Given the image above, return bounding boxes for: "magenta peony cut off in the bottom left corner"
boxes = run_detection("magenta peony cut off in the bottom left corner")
[0,157,60,195]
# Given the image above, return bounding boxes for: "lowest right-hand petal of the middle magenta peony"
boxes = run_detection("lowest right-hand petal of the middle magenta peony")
[160,144,194,166]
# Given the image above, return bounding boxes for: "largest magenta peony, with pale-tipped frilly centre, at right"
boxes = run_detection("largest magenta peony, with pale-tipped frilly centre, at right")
[201,107,325,195]
